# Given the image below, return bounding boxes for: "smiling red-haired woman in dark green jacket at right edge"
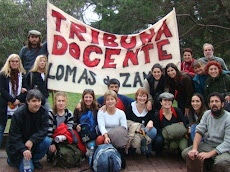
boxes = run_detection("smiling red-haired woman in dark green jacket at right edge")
[204,61,230,101]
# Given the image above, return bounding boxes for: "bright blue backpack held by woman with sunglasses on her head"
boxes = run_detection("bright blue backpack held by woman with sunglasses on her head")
[79,111,97,142]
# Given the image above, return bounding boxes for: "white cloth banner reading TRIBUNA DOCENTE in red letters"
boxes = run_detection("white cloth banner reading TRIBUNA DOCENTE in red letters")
[47,3,180,94]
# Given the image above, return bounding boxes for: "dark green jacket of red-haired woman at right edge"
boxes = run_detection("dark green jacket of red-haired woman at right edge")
[204,73,230,100]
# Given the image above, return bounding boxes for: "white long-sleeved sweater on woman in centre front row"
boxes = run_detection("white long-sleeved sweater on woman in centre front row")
[97,108,127,135]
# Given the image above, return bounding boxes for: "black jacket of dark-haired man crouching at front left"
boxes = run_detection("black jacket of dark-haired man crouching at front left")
[6,104,49,166]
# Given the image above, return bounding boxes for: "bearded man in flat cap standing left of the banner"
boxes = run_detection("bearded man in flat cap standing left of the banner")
[19,30,48,73]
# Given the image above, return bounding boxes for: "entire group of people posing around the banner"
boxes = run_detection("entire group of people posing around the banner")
[0,30,230,171]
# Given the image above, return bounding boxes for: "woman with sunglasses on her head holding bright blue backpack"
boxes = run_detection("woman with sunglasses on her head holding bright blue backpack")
[73,89,99,152]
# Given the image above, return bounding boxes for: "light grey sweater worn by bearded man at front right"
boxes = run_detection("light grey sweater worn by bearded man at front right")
[196,110,230,154]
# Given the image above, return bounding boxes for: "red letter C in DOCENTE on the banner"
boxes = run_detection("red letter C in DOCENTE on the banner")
[83,45,102,67]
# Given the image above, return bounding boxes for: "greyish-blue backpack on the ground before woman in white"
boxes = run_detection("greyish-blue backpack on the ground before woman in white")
[92,144,121,172]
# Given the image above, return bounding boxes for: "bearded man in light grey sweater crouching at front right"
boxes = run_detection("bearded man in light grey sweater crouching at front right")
[182,92,230,172]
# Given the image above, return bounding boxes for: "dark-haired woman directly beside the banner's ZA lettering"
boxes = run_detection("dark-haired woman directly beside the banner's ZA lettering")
[143,63,165,111]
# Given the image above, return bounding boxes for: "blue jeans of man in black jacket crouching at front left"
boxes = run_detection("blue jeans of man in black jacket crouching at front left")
[19,136,52,172]
